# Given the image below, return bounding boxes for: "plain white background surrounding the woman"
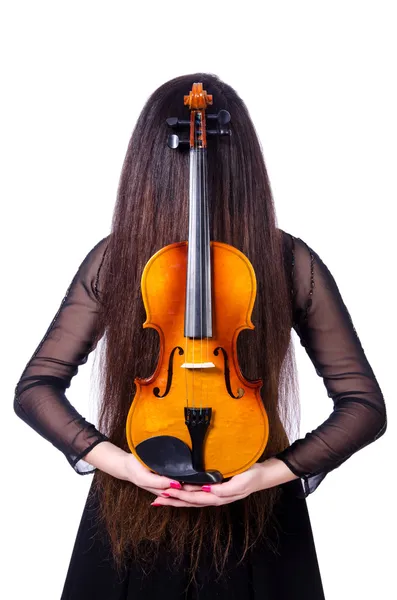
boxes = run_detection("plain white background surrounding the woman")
[0,0,397,600]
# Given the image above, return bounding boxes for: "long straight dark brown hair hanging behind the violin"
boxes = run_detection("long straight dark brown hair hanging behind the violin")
[94,73,299,574]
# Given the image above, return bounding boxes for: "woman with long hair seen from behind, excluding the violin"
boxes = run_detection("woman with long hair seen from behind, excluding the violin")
[15,73,386,600]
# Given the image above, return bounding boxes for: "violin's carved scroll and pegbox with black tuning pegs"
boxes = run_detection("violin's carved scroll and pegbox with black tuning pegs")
[166,82,231,150]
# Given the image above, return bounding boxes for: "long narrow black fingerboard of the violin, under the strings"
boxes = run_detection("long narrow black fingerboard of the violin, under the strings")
[185,148,212,339]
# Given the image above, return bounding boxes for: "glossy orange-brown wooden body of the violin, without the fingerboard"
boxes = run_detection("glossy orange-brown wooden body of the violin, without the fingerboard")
[126,241,269,480]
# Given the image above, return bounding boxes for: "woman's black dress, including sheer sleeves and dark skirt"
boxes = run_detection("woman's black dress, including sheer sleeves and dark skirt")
[14,232,387,600]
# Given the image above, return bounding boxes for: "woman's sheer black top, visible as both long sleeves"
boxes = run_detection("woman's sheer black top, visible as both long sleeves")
[14,232,387,496]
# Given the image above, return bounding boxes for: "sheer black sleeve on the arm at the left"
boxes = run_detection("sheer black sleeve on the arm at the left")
[14,236,109,474]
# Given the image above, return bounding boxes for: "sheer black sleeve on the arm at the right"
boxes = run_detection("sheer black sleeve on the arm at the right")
[276,232,387,497]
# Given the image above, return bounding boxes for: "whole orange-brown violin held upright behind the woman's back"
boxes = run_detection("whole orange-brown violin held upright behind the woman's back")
[126,83,269,484]
